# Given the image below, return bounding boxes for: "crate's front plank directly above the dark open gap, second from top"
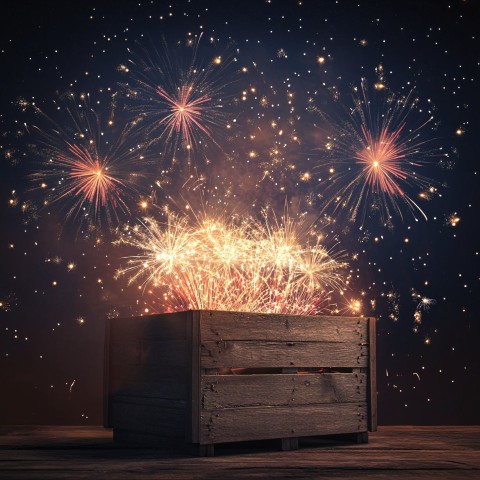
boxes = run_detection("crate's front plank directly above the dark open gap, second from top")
[201,341,368,368]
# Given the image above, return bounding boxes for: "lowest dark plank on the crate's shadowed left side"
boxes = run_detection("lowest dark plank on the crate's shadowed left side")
[113,401,185,438]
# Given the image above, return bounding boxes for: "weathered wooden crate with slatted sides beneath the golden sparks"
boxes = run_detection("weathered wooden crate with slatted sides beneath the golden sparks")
[105,310,377,455]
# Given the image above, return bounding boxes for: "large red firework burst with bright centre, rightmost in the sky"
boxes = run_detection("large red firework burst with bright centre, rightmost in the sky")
[316,80,438,224]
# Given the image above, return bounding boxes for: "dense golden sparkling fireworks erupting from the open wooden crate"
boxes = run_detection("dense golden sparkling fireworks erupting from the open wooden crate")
[114,206,345,314]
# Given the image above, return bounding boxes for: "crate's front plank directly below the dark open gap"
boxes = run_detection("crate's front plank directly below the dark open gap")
[201,373,367,410]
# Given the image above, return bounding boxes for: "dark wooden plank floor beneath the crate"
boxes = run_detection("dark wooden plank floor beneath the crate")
[0,426,480,480]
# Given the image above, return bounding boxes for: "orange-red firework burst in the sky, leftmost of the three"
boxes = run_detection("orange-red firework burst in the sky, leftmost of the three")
[31,95,145,230]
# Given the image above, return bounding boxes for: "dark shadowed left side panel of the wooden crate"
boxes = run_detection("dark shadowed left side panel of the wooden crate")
[109,312,191,438]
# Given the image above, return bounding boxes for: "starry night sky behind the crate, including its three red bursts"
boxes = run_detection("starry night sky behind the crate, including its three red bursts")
[0,0,480,424]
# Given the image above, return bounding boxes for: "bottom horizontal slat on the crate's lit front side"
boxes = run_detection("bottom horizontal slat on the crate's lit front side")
[199,403,368,444]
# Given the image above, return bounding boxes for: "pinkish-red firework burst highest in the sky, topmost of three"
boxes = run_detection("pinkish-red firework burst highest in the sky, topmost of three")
[120,35,229,163]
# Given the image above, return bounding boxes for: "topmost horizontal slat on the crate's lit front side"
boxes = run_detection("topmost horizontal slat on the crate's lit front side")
[200,311,368,343]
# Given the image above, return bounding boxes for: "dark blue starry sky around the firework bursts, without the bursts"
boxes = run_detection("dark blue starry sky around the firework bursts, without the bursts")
[0,0,480,424]
